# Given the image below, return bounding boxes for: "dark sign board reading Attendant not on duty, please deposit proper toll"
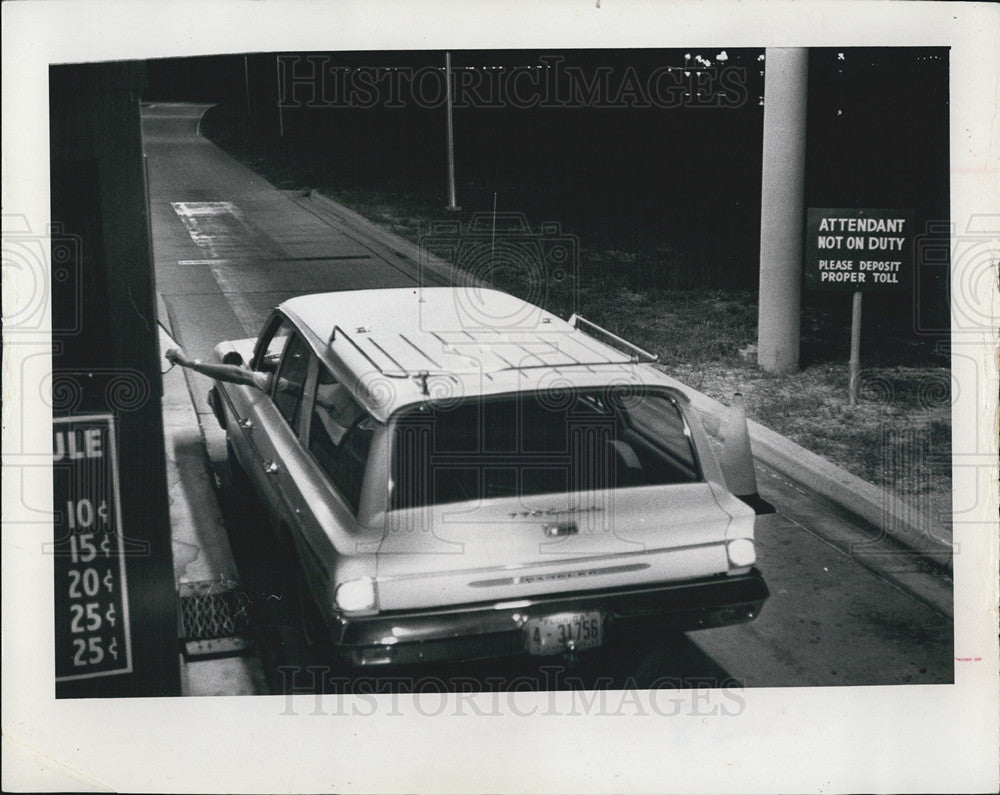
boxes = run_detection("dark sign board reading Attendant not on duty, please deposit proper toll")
[805,207,914,291]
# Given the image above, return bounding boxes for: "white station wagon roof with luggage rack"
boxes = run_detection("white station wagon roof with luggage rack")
[278,287,659,422]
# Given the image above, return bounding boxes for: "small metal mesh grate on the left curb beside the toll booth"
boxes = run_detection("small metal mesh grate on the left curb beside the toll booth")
[177,580,251,658]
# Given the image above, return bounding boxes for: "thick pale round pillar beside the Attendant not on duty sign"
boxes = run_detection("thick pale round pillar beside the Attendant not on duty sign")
[757,47,809,373]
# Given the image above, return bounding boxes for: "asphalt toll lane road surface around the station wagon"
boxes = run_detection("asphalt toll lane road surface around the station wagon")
[143,104,954,690]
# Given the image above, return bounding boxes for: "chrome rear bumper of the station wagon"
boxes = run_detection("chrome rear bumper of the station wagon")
[334,569,768,666]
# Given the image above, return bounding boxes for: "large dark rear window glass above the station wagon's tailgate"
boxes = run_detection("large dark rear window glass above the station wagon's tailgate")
[390,391,701,509]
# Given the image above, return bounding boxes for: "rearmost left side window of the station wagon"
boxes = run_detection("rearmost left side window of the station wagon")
[309,367,375,513]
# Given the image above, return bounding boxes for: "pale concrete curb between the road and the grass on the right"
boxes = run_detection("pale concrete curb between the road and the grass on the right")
[308,190,953,570]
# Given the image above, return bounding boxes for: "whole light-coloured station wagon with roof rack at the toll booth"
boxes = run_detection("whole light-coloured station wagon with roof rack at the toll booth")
[210,287,768,665]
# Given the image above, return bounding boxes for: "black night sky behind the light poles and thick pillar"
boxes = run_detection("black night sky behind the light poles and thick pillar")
[145,48,949,324]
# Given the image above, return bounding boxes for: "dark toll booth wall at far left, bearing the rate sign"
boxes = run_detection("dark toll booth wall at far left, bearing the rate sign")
[49,61,181,698]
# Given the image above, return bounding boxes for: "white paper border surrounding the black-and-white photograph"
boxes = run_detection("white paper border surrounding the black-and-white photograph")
[2,0,1000,792]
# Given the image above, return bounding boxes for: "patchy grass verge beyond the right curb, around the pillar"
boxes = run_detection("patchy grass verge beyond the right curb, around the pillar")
[197,105,951,529]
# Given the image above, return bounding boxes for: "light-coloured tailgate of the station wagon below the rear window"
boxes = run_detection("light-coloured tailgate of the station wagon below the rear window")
[378,483,732,610]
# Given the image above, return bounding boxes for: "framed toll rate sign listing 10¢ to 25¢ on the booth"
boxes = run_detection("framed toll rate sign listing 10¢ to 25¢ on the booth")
[51,414,132,682]
